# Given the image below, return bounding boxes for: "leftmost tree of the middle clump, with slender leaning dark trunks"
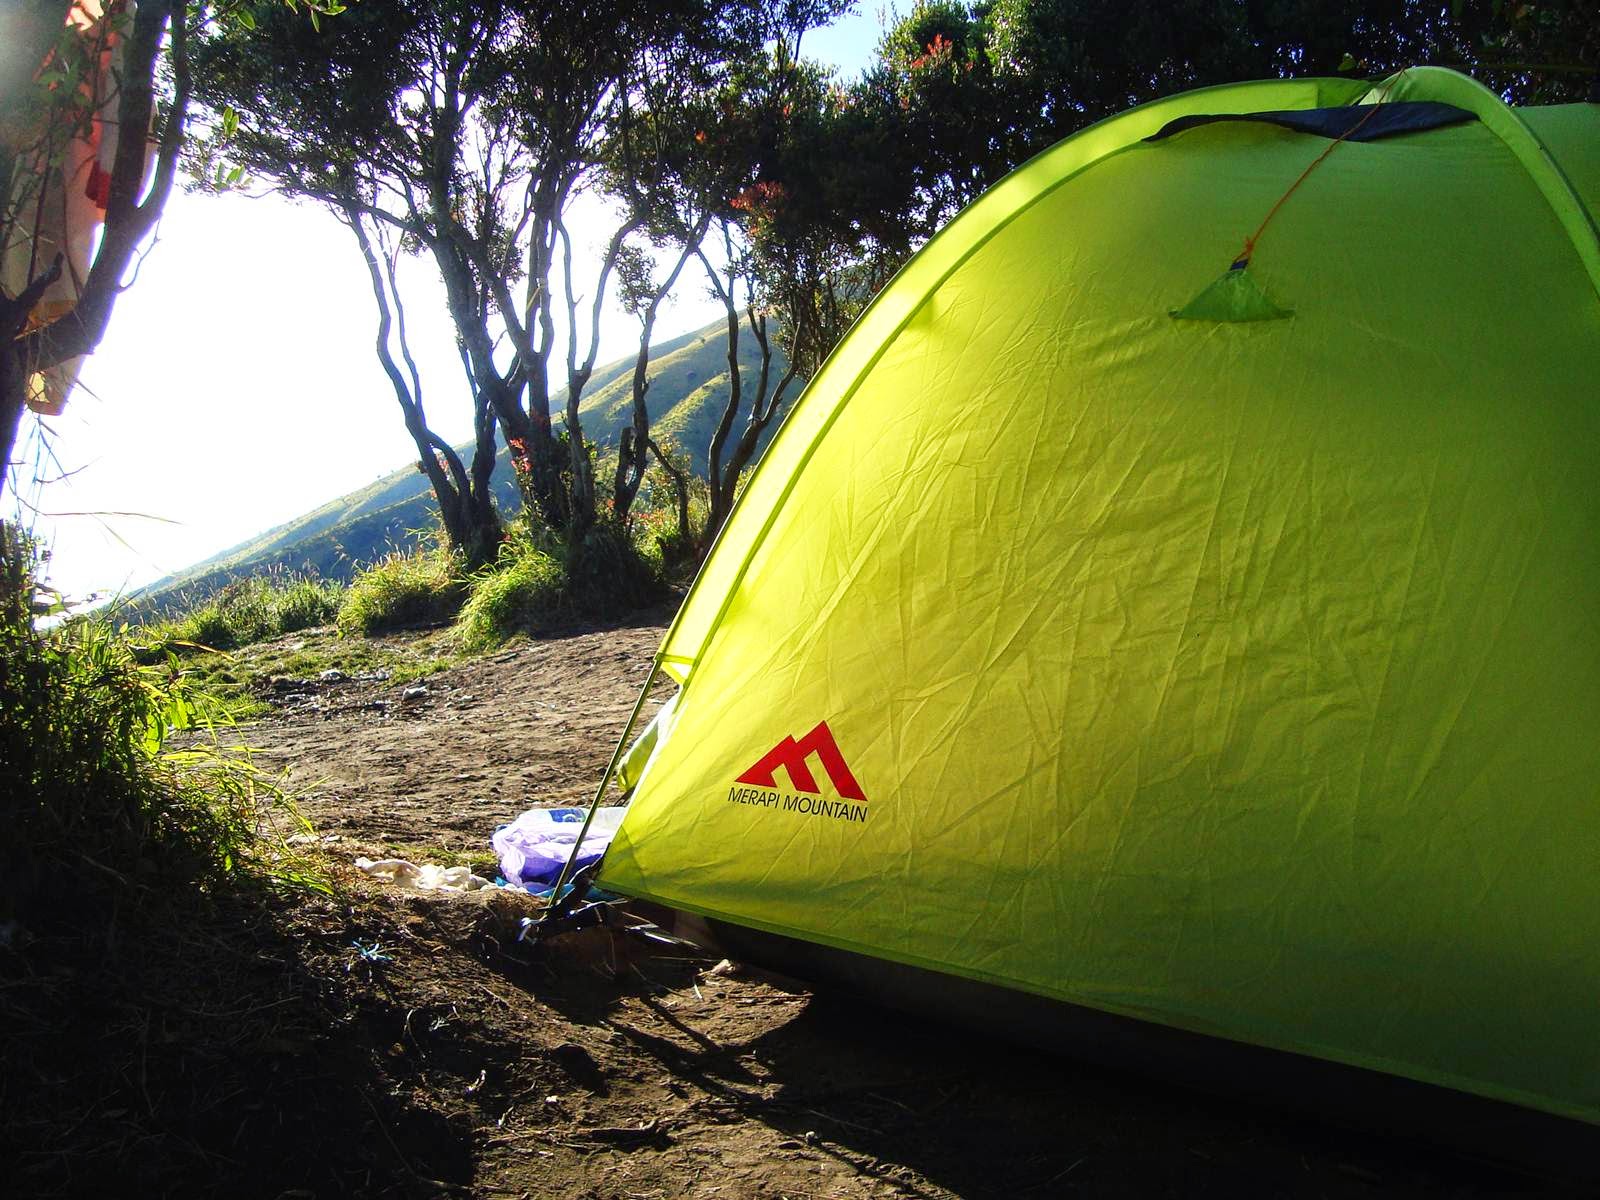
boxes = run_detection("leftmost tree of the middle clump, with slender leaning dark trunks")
[194,3,522,566]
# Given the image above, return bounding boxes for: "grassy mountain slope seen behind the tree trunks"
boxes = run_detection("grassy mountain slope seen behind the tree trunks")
[133,322,794,610]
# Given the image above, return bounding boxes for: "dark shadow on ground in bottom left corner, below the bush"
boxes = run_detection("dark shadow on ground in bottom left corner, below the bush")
[0,894,472,1197]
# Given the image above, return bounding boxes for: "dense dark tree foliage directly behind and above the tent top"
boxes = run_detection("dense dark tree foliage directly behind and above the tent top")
[749,0,1600,390]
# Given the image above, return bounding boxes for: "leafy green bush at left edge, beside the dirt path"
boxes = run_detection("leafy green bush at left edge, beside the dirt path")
[0,526,316,922]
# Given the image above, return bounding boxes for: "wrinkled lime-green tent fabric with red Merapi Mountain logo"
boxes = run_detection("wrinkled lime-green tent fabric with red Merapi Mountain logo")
[598,69,1600,1123]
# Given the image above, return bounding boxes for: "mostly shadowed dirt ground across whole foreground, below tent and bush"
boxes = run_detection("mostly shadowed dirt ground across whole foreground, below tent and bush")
[0,890,1568,1200]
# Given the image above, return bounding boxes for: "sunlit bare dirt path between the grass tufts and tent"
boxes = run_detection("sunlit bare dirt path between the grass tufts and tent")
[250,613,670,856]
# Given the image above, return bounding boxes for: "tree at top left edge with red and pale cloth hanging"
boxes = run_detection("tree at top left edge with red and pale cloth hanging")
[0,0,339,499]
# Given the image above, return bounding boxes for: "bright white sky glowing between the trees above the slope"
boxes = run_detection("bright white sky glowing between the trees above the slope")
[18,0,882,598]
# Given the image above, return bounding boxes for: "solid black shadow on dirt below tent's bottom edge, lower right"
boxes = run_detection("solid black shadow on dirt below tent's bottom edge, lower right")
[732,997,1538,1197]
